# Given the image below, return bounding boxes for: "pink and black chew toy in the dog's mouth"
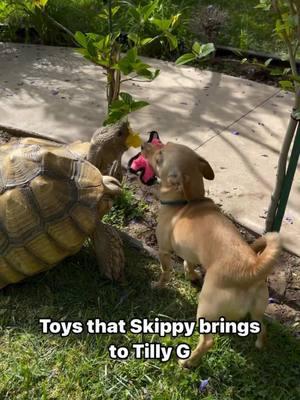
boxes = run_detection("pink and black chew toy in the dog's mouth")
[128,131,163,186]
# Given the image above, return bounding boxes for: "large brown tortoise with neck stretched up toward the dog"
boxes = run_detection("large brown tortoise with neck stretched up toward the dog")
[0,121,139,288]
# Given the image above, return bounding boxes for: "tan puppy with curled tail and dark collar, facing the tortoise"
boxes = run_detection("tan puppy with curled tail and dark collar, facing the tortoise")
[142,143,280,367]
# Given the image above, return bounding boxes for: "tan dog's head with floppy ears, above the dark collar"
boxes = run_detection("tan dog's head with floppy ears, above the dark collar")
[142,142,215,201]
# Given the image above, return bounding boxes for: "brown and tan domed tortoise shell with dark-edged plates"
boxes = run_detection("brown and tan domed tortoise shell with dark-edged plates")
[0,138,104,288]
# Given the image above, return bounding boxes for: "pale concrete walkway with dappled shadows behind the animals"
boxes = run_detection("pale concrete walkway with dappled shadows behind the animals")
[0,44,300,255]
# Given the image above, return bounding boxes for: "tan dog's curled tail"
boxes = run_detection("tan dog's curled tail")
[246,232,281,281]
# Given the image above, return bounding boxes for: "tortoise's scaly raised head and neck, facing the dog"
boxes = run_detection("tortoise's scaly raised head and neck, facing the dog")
[87,120,138,174]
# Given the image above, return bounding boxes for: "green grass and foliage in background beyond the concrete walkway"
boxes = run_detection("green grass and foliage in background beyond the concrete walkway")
[0,0,284,59]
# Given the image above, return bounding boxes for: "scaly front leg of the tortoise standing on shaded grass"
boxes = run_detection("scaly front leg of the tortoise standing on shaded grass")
[92,220,125,281]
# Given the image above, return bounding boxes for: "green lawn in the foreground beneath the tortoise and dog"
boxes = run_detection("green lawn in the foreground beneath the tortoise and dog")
[0,247,300,400]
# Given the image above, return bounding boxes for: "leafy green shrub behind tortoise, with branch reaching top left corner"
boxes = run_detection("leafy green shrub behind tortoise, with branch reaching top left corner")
[1,0,214,124]
